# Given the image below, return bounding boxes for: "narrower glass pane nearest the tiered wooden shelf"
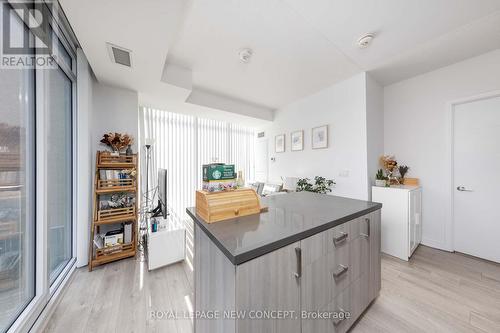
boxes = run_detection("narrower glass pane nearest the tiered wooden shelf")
[45,59,73,284]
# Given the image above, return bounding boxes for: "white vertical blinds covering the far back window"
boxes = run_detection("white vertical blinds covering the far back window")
[139,108,255,219]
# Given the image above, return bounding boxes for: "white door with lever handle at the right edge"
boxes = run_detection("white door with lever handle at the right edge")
[454,97,500,262]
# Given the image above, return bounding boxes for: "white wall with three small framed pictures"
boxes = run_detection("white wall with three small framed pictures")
[263,73,368,199]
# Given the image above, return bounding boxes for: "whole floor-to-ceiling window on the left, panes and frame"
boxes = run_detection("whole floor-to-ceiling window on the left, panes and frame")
[0,2,76,332]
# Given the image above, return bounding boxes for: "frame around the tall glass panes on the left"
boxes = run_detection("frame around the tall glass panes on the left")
[3,0,78,332]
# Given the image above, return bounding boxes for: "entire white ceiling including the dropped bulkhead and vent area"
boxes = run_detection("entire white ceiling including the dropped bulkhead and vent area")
[60,0,500,122]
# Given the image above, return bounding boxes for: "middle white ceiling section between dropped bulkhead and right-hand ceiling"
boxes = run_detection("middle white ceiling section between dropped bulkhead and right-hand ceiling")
[169,0,359,108]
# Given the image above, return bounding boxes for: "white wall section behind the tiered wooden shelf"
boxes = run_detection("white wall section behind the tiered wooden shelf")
[76,71,139,267]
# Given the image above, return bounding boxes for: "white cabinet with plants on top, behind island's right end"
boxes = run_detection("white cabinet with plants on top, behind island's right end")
[372,186,422,261]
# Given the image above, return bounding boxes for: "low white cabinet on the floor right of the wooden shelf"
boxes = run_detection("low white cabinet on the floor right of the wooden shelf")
[146,216,186,270]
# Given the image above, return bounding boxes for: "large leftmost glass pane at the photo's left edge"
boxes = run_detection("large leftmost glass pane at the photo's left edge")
[0,14,36,332]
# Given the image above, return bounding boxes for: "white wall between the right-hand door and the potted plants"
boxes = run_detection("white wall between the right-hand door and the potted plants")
[384,50,500,250]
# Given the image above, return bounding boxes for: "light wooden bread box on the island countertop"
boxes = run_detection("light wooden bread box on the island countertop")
[196,189,261,223]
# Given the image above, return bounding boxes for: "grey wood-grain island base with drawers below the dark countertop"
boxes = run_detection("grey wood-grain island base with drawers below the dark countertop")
[195,210,381,333]
